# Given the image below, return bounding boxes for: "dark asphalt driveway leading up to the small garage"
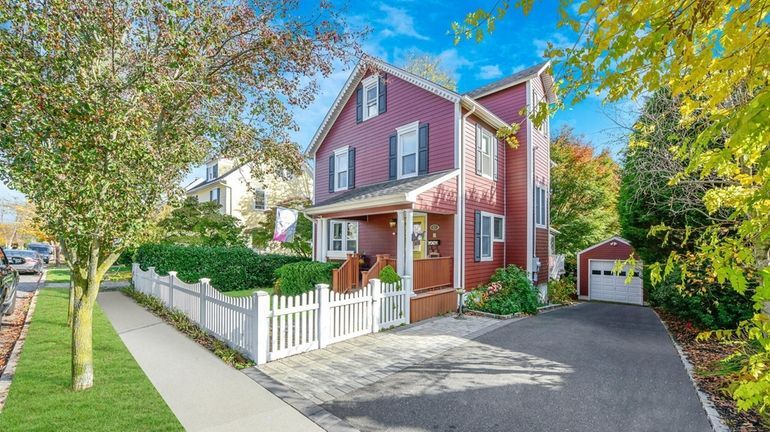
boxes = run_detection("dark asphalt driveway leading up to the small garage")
[323,303,711,432]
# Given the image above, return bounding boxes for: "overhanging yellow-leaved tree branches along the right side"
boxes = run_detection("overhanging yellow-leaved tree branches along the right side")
[452,0,770,413]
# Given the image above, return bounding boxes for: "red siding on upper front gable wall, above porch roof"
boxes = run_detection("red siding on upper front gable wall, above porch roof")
[315,75,454,202]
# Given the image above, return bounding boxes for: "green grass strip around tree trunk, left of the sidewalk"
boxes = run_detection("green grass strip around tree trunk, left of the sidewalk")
[0,289,182,431]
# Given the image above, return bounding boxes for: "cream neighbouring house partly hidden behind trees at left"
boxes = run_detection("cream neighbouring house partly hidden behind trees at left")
[186,158,313,241]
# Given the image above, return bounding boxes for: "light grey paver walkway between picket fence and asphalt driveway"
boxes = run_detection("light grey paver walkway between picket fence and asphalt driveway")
[258,316,510,404]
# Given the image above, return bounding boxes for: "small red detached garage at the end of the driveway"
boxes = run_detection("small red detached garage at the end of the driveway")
[577,237,644,305]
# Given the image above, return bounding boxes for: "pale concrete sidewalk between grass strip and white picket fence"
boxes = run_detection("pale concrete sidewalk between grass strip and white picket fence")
[99,292,322,431]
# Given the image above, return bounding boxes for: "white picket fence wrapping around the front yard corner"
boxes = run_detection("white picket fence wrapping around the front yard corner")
[132,263,413,364]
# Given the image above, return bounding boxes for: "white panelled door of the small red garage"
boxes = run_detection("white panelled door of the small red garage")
[588,260,642,304]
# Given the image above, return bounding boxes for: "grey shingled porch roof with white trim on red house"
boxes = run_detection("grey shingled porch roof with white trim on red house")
[305,169,460,215]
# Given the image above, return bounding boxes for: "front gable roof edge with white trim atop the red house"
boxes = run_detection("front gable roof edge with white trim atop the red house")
[306,55,509,156]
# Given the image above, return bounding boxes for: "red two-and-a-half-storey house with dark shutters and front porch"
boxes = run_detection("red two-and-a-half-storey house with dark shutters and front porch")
[306,58,556,292]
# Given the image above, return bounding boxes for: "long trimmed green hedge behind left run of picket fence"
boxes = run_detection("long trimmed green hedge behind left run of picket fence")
[136,244,307,291]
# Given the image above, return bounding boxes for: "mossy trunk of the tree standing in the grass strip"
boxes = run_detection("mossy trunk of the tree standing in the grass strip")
[72,287,94,391]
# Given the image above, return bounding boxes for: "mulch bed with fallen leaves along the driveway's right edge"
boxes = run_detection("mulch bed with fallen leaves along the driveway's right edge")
[657,309,770,432]
